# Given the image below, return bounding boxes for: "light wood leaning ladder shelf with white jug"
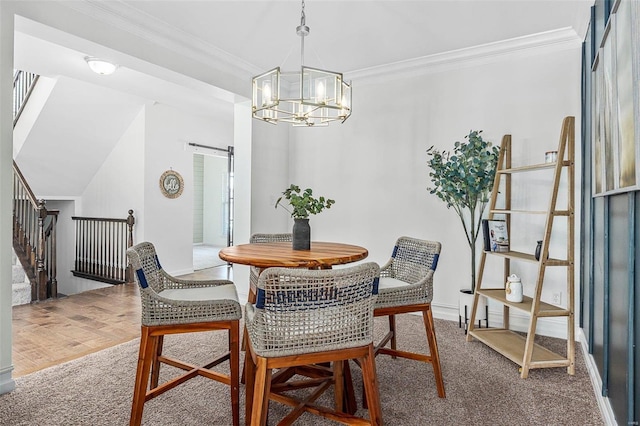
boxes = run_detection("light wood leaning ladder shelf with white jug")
[467,117,575,379]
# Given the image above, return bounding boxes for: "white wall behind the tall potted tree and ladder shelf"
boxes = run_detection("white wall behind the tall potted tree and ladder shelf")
[253,35,581,334]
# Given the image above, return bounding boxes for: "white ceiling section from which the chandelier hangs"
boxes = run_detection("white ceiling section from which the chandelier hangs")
[112,0,592,72]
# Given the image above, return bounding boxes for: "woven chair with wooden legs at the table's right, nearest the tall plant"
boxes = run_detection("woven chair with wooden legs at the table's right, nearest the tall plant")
[374,237,445,398]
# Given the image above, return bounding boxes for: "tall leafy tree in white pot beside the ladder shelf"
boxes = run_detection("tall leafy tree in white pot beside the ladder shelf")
[427,130,499,330]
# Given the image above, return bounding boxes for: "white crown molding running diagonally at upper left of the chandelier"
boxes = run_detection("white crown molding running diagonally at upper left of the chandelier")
[57,0,260,77]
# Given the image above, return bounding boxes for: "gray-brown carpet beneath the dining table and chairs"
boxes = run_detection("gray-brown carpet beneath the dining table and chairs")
[0,315,603,426]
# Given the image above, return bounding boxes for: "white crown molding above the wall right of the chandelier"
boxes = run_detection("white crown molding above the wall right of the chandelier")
[345,27,582,85]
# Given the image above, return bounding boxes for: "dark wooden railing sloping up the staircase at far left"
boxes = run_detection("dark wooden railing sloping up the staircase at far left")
[13,161,58,301]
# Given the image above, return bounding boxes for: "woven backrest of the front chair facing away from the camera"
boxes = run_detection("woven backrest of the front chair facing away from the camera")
[247,262,380,357]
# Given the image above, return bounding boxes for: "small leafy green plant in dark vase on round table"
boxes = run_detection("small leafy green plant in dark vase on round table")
[275,184,335,250]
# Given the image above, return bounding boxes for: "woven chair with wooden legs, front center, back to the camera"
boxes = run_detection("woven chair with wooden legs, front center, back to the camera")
[245,262,382,425]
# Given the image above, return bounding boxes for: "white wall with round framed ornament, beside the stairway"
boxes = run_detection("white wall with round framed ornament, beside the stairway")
[75,103,233,284]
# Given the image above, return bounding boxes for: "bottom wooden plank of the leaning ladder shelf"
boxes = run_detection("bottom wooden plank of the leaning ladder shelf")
[469,328,569,368]
